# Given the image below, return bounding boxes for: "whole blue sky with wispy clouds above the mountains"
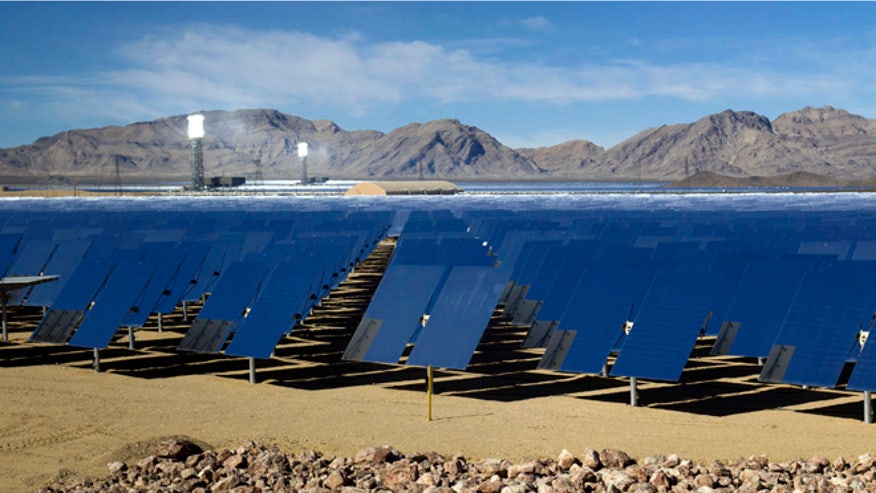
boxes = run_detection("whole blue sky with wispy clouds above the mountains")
[0,2,876,148]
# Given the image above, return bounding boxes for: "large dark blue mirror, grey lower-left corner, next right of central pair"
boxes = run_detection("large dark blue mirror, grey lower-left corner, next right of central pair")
[539,267,654,373]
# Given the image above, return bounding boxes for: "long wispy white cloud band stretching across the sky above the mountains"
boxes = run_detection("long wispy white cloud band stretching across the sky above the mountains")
[0,22,876,129]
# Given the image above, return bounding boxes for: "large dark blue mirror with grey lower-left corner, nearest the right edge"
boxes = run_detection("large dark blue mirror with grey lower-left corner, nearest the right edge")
[761,261,876,387]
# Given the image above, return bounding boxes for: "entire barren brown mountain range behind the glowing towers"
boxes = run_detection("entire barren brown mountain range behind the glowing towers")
[0,106,876,182]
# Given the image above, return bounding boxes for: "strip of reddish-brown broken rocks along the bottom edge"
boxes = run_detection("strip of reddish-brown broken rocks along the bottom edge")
[40,440,876,493]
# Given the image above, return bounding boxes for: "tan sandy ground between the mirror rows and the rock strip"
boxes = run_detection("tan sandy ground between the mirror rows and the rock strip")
[0,240,876,492]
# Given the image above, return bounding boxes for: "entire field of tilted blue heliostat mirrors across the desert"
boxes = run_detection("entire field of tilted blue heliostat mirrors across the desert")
[0,206,876,416]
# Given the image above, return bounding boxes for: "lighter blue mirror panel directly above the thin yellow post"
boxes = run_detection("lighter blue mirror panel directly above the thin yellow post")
[407,266,511,369]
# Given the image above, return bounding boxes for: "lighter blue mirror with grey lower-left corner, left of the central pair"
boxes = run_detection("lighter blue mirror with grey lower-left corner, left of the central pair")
[344,264,446,364]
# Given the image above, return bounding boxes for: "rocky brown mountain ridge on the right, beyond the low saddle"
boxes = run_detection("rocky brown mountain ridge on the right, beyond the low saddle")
[591,106,876,180]
